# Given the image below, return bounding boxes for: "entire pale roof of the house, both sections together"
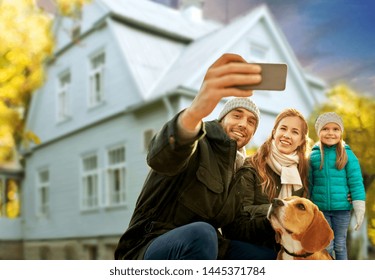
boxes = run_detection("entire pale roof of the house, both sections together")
[57,0,323,107]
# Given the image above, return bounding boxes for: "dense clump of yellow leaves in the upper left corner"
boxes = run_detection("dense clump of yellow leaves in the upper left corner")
[0,0,53,106]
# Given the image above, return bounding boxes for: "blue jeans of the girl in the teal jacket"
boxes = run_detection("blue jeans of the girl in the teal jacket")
[322,210,350,260]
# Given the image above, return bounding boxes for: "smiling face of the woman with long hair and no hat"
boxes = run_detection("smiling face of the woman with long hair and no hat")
[273,116,304,154]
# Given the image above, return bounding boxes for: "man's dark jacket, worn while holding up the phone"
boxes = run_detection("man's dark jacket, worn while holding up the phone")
[115,112,264,259]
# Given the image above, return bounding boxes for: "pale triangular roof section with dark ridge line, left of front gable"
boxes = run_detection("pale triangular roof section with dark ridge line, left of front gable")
[98,0,222,101]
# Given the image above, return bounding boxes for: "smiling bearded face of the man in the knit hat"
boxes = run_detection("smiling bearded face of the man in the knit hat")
[221,108,257,149]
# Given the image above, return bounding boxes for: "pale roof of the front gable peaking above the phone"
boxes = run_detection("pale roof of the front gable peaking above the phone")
[147,5,324,108]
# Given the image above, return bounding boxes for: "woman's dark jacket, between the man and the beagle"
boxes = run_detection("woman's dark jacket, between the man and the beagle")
[223,161,304,250]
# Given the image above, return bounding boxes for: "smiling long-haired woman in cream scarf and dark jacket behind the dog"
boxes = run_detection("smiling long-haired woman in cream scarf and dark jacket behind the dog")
[224,109,308,252]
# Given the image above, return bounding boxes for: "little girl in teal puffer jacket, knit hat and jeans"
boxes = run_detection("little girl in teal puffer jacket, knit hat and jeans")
[309,112,366,260]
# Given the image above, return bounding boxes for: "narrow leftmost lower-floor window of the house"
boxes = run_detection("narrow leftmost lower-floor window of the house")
[37,169,50,217]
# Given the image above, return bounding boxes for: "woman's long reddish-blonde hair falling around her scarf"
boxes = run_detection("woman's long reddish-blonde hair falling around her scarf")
[248,108,309,201]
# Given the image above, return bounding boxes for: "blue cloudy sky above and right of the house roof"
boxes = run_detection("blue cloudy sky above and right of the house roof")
[156,0,375,97]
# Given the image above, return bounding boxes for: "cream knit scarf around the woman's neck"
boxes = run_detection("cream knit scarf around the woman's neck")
[267,140,302,199]
